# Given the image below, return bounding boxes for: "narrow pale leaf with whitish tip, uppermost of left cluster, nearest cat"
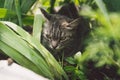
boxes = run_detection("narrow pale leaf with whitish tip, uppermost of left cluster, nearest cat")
[0,22,68,80]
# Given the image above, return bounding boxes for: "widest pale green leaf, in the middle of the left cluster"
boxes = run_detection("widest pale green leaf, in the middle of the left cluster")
[0,23,53,79]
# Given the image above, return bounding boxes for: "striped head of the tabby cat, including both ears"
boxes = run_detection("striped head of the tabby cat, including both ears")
[41,9,80,50]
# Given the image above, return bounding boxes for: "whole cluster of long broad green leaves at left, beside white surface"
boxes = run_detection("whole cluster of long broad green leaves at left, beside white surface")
[0,17,67,79]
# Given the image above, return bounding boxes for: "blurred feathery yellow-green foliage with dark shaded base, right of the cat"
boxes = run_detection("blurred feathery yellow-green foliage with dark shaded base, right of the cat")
[63,0,120,80]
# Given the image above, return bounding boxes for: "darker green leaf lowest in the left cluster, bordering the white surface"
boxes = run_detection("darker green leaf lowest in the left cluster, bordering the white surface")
[0,40,41,74]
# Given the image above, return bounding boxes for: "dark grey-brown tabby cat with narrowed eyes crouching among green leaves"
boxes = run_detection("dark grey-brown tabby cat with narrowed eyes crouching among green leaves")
[41,9,89,56]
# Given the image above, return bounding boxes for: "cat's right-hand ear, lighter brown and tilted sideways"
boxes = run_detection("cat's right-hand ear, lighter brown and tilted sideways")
[66,18,81,29]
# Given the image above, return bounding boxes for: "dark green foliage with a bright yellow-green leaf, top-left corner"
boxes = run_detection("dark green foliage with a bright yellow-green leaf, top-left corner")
[0,0,37,27]
